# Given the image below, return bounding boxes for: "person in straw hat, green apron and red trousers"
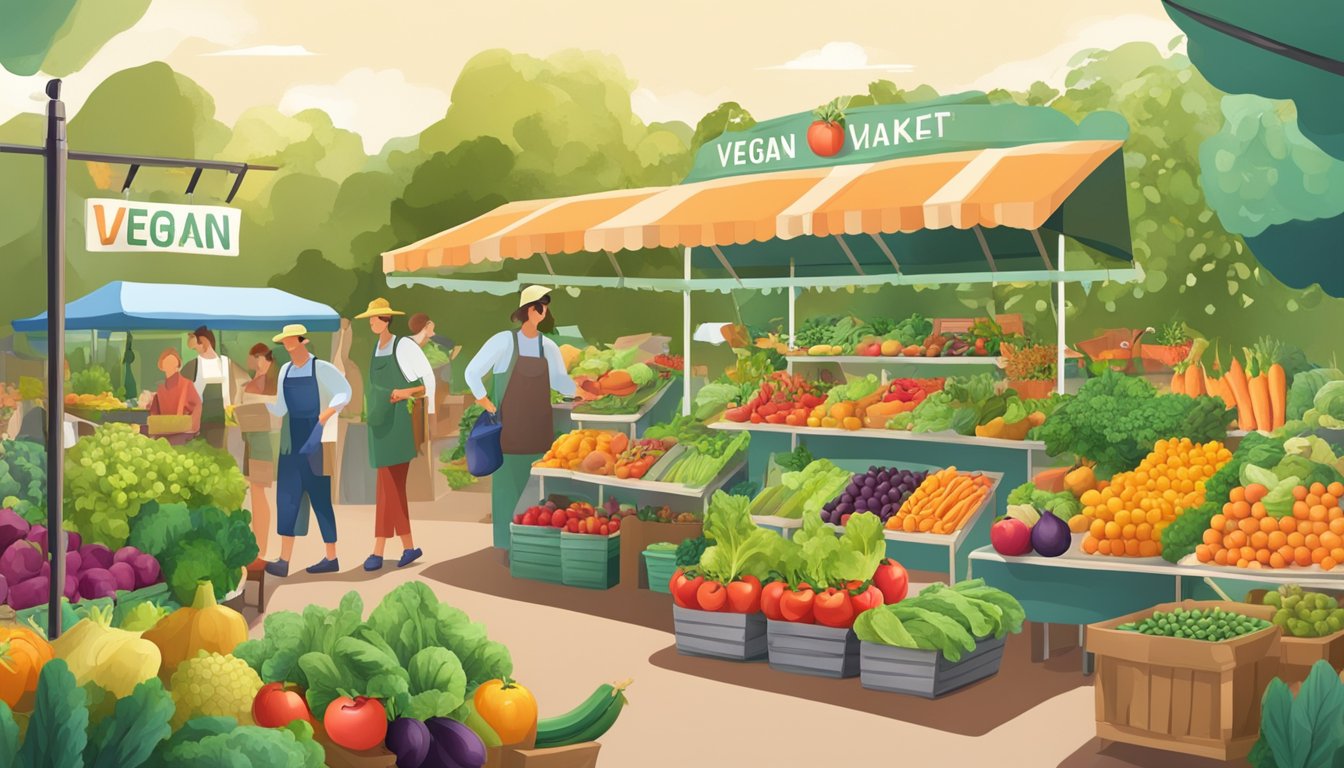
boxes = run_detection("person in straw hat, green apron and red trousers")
[355,299,429,570]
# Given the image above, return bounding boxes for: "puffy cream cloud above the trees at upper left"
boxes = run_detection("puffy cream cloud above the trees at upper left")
[280,69,449,155]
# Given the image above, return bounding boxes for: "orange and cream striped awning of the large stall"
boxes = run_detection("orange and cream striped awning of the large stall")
[383,140,1121,273]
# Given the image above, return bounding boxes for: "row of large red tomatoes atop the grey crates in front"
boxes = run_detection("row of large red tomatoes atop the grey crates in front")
[668,558,910,628]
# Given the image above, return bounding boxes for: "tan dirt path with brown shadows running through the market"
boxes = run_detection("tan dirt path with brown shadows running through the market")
[254,494,1222,768]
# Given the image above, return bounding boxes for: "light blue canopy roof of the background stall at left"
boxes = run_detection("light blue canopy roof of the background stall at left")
[13,280,340,334]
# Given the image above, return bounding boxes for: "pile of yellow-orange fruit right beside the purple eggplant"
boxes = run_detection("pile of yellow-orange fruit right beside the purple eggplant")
[1068,437,1232,557]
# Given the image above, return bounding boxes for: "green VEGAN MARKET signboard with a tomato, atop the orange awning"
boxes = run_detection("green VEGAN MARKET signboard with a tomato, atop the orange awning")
[685,93,1129,182]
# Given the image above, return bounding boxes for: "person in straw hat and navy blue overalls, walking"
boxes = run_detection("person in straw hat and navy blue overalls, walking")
[266,324,351,576]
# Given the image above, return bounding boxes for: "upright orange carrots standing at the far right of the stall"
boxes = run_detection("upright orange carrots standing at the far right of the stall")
[1171,339,1288,432]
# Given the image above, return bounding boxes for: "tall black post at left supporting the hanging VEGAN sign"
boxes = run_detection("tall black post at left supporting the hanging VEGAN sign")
[44,79,67,638]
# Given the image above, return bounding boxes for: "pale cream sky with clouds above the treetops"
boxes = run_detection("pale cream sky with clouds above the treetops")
[0,0,1180,152]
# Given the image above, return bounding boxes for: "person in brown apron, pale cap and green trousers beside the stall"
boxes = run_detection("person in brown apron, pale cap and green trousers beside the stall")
[465,285,577,550]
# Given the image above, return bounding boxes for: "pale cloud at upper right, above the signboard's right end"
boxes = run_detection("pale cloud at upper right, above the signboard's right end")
[965,15,1185,90]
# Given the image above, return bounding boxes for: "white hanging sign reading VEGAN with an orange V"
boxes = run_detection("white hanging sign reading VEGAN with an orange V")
[85,199,242,256]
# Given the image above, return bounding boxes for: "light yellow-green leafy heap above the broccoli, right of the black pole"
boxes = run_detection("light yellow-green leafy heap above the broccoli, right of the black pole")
[65,424,247,548]
